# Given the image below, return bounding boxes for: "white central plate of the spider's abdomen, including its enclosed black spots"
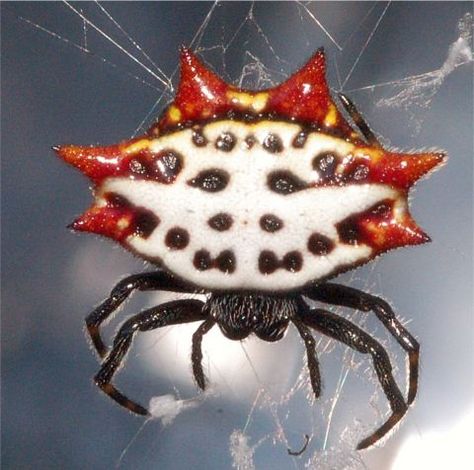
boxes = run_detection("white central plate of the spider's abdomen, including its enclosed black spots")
[99,120,399,291]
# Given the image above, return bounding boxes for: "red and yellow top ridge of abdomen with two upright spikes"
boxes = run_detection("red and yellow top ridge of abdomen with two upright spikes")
[148,47,356,137]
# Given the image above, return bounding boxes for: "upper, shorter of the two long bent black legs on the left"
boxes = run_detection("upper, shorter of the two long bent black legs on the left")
[86,271,192,358]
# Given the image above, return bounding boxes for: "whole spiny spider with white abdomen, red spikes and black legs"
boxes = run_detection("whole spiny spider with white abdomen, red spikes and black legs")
[54,48,444,449]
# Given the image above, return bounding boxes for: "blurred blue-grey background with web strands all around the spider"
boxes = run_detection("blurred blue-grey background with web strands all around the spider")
[1,2,474,470]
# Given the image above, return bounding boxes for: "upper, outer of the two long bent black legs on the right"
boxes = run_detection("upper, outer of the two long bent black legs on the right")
[305,283,420,405]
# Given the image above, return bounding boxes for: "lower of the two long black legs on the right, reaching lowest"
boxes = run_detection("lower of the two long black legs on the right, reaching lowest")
[298,309,408,450]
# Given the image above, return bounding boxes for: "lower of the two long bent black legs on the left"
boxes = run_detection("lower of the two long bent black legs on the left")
[94,299,206,415]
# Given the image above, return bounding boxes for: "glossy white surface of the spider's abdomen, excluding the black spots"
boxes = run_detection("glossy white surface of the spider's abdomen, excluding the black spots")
[100,121,405,290]
